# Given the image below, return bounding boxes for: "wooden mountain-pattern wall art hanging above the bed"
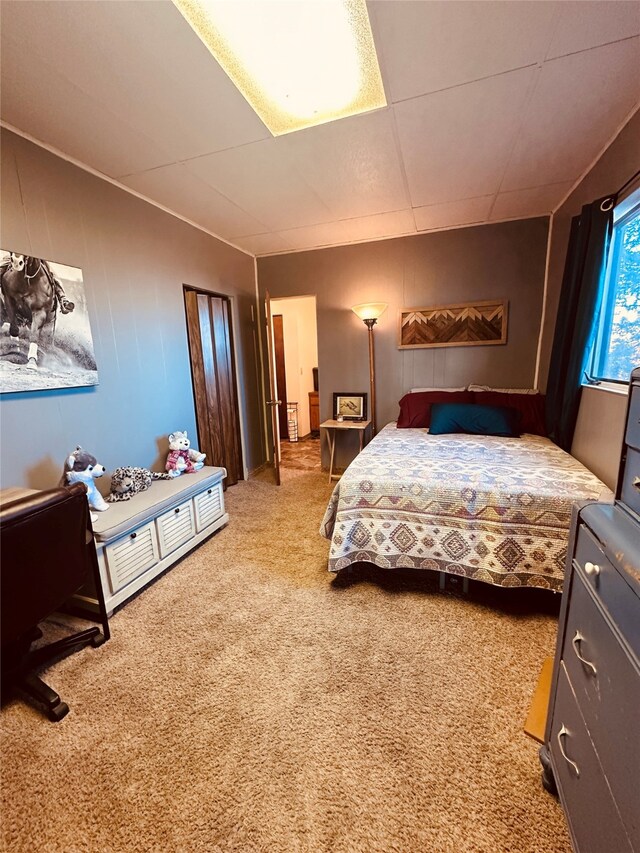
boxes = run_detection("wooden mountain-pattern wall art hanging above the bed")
[398,299,509,349]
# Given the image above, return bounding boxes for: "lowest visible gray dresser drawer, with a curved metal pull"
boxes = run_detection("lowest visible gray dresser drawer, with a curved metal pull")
[549,665,633,853]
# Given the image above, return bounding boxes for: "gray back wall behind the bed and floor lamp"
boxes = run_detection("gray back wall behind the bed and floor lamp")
[258,218,548,463]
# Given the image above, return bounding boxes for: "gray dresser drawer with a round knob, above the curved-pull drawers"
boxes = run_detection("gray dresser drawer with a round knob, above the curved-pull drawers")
[575,524,638,648]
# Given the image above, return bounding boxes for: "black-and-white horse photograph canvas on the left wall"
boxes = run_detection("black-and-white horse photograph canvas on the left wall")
[0,250,98,393]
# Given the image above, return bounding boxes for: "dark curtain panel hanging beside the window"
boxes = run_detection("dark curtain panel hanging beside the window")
[546,196,615,451]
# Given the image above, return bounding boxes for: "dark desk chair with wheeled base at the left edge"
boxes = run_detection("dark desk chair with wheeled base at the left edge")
[0,483,110,722]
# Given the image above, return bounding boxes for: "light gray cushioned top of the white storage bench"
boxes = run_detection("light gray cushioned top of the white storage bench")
[93,465,227,542]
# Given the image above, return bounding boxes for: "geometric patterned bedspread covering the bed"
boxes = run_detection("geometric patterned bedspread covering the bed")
[320,424,613,590]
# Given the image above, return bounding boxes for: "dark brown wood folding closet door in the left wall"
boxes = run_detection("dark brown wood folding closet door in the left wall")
[185,289,243,486]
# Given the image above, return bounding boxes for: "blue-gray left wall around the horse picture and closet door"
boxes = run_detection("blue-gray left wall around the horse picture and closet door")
[0,130,264,489]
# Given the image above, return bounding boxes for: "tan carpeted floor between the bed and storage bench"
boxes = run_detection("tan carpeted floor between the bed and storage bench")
[0,473,570,853]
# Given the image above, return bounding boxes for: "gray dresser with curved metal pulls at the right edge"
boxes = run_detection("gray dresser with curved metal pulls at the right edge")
[540,369,640,853]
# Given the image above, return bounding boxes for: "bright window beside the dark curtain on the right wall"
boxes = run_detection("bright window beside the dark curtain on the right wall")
[589,192,640,383]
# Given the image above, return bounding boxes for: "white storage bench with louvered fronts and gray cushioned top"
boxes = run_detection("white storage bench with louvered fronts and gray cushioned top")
[76,466,229,614]
